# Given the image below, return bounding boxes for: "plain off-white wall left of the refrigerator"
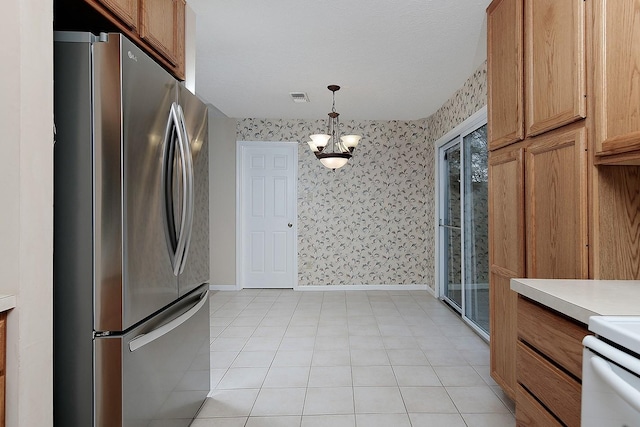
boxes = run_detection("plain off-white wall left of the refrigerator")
[0,0,53,427]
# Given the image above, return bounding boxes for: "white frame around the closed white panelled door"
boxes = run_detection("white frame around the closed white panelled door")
[236,141,298,290]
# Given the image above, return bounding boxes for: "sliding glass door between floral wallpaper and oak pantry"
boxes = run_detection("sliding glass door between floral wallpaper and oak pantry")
[438,121,489,337]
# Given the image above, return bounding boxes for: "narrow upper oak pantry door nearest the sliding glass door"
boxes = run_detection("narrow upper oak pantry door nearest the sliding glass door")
[487,0,524,150]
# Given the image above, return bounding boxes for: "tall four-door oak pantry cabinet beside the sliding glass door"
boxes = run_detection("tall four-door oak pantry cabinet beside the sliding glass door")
[487,0,588,398]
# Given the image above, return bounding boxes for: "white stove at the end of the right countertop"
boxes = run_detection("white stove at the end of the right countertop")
[581,316,640,427]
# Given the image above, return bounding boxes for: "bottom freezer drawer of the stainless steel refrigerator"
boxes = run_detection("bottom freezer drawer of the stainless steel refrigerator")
[95,286,210,427]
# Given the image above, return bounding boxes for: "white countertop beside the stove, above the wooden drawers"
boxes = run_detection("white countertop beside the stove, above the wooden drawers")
[511,279,640,325]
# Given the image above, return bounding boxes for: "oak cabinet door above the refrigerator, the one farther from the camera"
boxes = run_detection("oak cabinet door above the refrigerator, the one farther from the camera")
[140,0,185,66]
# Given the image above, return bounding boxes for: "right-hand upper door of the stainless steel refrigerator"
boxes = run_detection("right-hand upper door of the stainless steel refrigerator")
[178,84,209,295]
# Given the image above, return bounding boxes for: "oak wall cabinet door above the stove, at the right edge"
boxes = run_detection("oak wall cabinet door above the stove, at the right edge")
[593,0,640,154]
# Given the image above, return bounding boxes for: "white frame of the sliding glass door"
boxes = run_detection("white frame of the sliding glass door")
[434,106,490,341]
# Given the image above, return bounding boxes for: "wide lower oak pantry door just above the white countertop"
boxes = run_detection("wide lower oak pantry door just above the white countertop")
[525,125,588,279]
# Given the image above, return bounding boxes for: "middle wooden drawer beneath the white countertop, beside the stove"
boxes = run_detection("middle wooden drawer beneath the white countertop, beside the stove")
[516,342,582,427]
